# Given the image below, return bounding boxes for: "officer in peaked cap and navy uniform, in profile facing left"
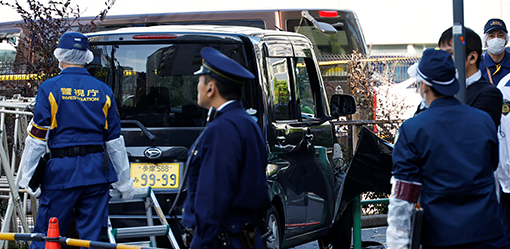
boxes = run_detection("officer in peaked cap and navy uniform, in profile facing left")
[182,47,270,248]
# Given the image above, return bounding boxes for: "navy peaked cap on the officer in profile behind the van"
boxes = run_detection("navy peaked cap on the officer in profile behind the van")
[195,47,255,85]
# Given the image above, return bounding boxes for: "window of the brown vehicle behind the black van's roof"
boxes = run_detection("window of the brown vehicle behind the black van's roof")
[287,18,365,54]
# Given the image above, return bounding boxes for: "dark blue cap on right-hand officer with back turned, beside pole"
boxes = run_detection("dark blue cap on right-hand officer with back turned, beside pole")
[417,48,460,96]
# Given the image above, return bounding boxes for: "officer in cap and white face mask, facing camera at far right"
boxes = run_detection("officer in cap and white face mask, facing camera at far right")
[480,19,510,87]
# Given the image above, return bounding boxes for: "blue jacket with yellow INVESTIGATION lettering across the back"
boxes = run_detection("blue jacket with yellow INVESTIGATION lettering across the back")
[31,67,120,190]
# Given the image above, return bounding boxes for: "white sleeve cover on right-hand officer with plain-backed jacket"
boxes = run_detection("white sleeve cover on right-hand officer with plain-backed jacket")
[386,196,414,249]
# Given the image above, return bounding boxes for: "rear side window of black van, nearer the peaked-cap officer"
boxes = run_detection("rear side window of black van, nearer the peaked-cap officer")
[267,58,296,120]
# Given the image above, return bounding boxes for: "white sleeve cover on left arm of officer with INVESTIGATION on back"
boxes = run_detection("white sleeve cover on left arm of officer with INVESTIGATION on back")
[19,135,46,188]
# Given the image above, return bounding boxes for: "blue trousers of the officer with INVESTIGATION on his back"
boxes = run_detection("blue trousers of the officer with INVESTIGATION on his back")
[30,183,110,249]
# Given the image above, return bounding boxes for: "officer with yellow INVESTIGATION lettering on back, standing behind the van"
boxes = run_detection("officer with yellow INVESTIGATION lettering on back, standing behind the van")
[19,32,133,248]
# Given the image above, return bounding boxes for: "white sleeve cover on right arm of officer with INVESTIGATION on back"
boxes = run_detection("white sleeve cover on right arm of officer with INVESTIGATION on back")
[106,135,133,196]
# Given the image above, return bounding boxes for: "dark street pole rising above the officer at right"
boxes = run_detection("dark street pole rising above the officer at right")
[453,0,466,103]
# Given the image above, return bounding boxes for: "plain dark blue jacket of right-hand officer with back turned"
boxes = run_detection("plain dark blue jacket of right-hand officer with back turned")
[393,97,503,246]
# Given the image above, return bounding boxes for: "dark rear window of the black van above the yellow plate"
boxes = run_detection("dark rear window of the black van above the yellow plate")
[87,44,246,127]
